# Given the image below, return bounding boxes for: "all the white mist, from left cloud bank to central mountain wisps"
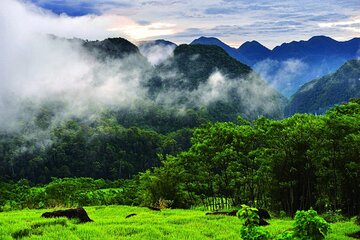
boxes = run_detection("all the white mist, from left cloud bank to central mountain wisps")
[0,0,286,136]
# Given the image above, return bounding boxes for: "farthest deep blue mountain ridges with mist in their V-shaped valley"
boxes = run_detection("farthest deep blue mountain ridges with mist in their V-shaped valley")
[191,36,360,96]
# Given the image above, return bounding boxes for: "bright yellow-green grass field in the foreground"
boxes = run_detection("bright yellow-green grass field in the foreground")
[0,206,360,240]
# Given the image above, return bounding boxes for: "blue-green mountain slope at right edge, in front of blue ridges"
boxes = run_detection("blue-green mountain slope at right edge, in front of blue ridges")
[285,60,360,115]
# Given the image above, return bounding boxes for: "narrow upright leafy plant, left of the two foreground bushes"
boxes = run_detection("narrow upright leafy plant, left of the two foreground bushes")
[237,205,271,240]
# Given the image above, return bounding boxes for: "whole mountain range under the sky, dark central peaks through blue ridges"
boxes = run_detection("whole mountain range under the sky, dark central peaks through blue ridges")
[76,37,360,117]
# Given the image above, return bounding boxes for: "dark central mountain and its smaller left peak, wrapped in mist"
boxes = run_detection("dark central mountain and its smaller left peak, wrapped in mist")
[79,38,287,121]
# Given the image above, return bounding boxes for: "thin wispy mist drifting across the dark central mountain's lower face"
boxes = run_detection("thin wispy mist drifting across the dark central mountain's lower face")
[155,69,286,118]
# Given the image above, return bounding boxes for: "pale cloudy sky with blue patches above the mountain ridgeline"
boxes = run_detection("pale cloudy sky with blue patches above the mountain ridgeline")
[9,0,360,48]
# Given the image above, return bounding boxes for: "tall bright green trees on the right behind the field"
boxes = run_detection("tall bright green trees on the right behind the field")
[140,99,360,215]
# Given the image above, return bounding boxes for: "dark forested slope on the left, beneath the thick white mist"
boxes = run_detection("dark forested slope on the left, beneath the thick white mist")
[0,113,194,183]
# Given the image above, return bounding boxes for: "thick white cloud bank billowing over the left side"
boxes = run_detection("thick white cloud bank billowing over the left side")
[0,0,153,130]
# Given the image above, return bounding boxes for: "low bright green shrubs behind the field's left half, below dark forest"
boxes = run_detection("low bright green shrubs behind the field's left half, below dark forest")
[0,178,128,211]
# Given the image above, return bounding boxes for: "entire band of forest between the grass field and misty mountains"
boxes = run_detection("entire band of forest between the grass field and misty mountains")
[0,99,360,215]
